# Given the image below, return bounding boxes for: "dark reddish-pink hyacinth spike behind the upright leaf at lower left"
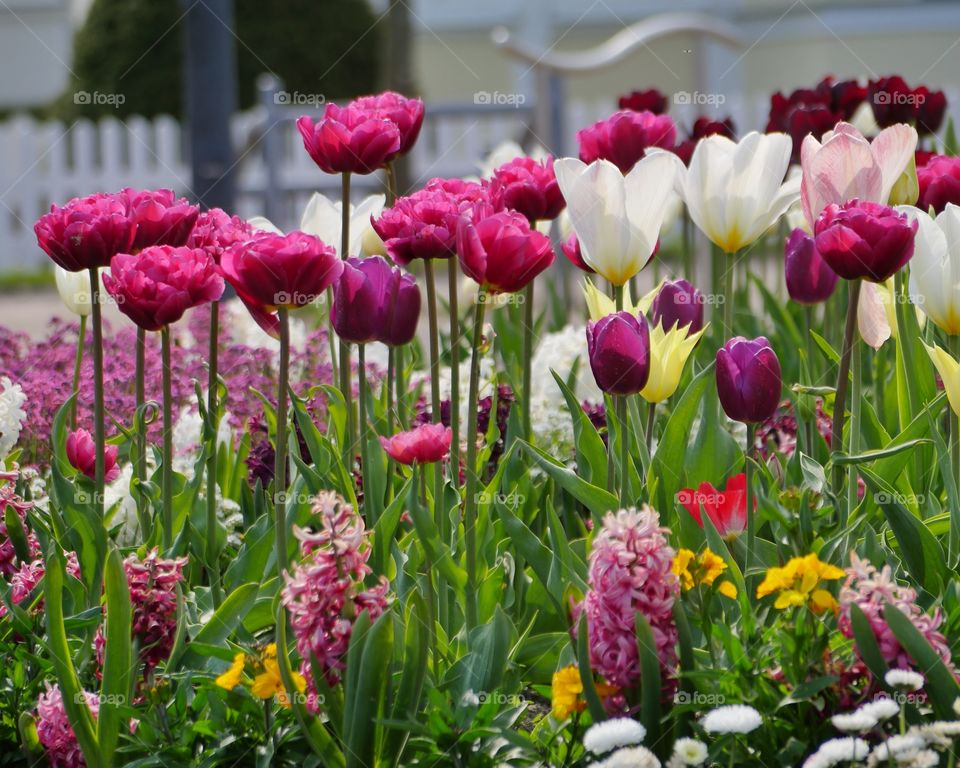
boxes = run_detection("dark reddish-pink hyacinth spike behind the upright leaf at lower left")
[94,548,187,676]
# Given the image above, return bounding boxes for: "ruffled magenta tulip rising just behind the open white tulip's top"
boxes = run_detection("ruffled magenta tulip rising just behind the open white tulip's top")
[577,110,677,174]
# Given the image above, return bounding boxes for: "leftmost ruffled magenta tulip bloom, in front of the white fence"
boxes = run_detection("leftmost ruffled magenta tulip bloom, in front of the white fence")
[33,194,135,272]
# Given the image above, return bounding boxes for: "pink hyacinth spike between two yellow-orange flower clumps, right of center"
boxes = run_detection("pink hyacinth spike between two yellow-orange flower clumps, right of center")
[575,506,680,688]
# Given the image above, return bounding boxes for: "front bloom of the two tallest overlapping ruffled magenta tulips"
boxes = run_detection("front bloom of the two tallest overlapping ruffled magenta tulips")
[297,104,400,174]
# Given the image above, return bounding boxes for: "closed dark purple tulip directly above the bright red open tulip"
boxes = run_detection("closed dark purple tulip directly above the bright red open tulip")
[716,336,783,423]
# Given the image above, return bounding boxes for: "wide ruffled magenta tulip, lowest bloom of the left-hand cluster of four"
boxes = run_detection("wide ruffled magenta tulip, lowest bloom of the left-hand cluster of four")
[103,245,223,331]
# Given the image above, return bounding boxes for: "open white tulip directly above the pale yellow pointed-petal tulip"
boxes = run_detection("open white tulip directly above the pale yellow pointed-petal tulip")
[553,152,683,285]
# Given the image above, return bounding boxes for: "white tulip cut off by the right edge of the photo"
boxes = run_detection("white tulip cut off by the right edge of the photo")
[897,203,960,335]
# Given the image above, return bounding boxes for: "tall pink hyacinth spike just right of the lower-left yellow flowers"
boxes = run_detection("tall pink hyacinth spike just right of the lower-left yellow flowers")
[282,491,389,711]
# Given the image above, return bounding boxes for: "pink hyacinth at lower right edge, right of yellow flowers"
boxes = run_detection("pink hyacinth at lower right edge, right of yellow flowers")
[838,552,956,674]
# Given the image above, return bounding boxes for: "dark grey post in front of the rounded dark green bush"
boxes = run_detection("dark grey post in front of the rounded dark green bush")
[181,0,237,212]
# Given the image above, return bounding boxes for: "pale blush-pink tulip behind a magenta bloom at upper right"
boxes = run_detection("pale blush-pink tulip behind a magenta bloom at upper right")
[800,123,917,230]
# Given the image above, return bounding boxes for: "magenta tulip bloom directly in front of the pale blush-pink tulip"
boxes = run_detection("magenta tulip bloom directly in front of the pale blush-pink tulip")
[816,200,918,283]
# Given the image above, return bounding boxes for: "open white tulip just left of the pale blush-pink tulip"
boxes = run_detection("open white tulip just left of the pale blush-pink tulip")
[683,132,800,253]
